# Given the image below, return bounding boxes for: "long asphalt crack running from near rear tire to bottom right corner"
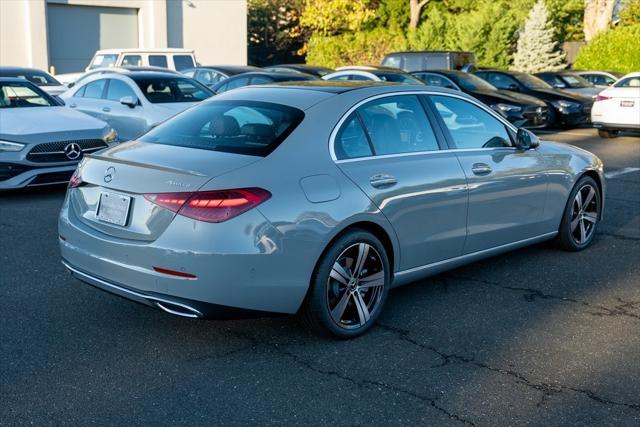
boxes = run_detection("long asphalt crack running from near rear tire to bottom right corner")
[377,323,640,411]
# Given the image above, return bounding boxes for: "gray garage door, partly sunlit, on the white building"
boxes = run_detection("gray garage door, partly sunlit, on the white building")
[47,4,138,74]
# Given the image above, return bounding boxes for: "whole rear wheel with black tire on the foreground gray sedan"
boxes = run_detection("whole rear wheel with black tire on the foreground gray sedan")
[301,229,391,339]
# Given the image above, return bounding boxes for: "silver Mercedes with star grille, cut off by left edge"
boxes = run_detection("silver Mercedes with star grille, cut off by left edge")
[0,77,118,190]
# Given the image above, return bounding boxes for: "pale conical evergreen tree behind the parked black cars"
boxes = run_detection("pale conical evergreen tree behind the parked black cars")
[512,0,565,73]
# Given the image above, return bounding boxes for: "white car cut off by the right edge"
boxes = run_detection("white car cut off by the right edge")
[591,72,640,138]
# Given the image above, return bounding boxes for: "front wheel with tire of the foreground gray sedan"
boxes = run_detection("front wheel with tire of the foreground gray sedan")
[556,176,602,252]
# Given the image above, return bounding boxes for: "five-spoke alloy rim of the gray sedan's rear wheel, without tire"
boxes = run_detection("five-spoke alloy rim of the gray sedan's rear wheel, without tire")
[327,243,385,329]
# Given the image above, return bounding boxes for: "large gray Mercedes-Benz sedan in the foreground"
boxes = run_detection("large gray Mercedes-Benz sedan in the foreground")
[59,82,604,338]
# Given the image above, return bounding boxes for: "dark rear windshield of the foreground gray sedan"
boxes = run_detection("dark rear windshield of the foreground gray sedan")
[140,101,304,157]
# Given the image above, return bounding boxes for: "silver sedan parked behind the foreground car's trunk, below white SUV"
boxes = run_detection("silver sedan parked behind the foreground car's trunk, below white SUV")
[60,72,213,141]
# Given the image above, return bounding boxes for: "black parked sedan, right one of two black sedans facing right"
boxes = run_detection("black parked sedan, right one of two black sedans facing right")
[475,70,593,126]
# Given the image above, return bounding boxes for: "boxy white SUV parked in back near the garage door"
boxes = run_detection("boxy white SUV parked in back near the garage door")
[56,48,197,85]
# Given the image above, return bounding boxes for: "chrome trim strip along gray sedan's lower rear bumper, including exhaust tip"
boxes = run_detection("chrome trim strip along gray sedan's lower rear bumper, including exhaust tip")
[62,259,204,319]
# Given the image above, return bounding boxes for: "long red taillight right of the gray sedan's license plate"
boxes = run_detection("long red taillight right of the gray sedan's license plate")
[144,188,271,226]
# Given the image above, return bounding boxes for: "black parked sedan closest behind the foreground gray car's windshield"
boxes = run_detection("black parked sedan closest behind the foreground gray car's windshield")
[411,70,551,128]
